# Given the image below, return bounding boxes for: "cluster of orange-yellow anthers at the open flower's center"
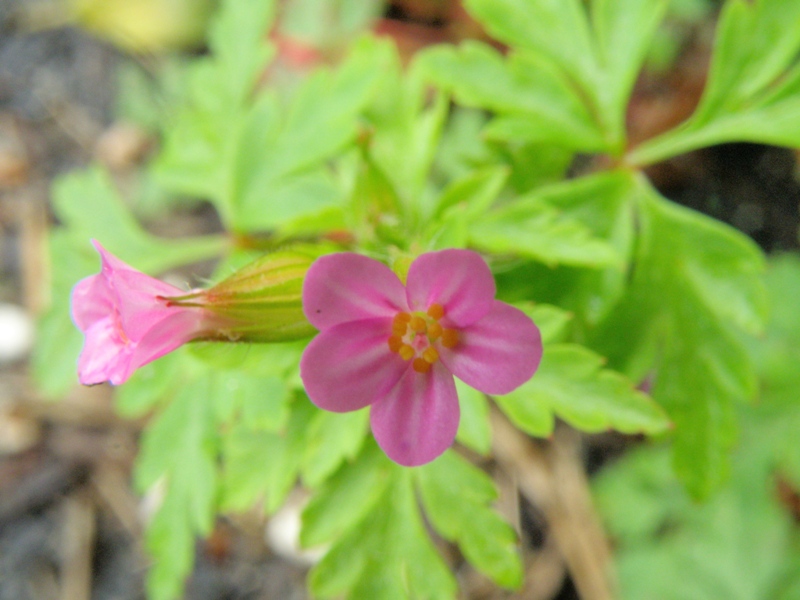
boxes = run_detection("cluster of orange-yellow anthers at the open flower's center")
[388,304,458,373]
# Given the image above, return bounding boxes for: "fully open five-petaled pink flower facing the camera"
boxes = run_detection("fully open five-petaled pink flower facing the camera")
[300,250,542,466]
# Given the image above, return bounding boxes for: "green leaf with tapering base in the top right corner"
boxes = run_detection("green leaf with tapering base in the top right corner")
[628,0,800,165]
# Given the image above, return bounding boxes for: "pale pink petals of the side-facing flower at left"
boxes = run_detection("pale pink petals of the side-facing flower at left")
[72,242,213,385]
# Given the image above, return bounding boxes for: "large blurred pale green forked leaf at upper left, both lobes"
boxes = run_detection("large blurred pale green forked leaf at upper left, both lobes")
[156,1,388,232]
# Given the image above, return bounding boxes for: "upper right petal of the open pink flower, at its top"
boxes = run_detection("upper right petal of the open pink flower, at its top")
[406,249,496,326]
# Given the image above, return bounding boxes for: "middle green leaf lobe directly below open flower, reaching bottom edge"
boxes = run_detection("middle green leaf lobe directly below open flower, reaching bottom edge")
[309,459,456,599]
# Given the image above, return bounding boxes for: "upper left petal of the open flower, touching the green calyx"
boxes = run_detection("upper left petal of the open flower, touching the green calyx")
[303,252,408,330]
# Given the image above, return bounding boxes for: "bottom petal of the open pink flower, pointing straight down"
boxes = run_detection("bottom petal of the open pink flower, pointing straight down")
[370,363,460,467]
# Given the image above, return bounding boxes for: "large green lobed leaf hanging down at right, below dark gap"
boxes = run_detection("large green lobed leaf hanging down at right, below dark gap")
[592,187,766,497]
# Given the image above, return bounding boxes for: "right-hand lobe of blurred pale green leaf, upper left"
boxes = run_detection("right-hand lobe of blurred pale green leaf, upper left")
[234,38,389,230]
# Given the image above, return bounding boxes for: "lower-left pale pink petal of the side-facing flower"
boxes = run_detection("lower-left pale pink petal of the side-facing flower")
[78,317,134,385]
